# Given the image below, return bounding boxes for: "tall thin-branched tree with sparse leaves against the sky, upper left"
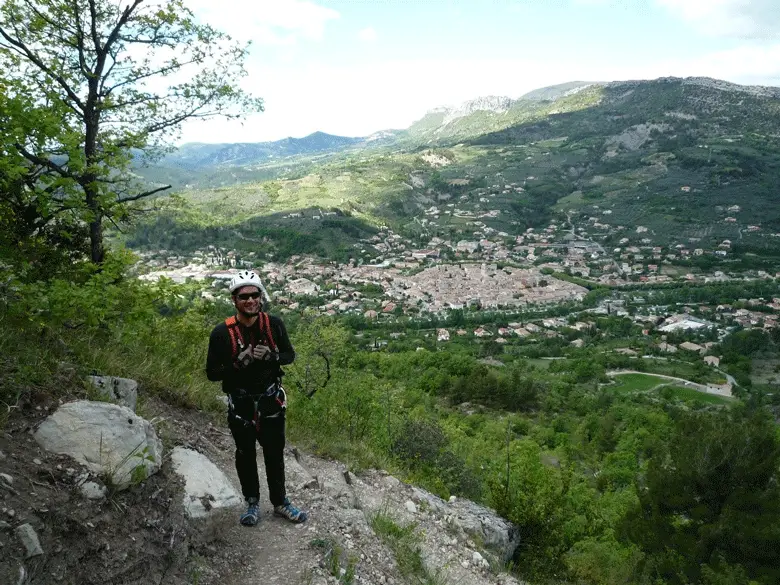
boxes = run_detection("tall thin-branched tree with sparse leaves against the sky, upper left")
[0,0,262,263]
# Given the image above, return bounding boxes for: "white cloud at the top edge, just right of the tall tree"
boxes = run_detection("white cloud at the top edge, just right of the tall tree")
[187,0,340,45]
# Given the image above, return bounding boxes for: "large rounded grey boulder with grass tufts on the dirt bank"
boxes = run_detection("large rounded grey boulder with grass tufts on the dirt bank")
[35,400,163,489]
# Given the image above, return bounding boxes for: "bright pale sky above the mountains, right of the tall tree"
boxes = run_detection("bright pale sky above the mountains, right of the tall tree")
[175,0,780,142]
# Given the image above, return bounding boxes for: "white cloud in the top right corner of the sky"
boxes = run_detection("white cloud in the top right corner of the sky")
[656,0,780,39]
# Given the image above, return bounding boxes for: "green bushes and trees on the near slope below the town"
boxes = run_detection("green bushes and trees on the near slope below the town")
[0,251,780,585]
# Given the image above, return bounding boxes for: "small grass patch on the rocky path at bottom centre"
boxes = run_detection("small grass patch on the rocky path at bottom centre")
[370,511,444,585]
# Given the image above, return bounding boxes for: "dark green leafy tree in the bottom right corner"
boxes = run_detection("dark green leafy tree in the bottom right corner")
[626,409,780,584]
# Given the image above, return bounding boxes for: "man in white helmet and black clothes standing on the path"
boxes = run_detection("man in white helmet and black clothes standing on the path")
[206,270,307,526]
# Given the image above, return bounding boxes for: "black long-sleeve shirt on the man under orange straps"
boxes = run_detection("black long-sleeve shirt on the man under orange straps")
[206,315,295,394]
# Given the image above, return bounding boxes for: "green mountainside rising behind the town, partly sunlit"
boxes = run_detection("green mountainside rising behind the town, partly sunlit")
[125,79,780,262]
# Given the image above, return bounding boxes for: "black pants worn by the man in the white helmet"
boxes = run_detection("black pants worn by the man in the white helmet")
[228,398,286,506]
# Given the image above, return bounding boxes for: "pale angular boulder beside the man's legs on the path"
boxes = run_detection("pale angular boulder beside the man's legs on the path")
[171,447,243,518]
